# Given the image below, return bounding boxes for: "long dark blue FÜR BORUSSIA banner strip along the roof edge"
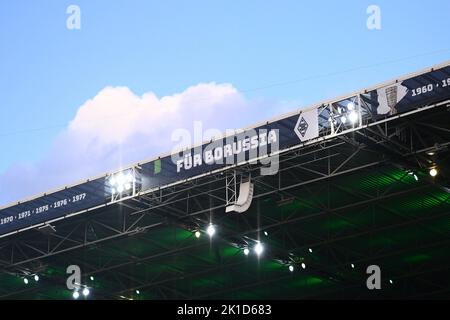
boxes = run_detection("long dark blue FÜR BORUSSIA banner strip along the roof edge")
[0,62,450,237]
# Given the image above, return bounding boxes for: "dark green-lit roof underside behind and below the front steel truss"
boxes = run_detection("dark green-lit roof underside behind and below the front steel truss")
[0,104,450,299]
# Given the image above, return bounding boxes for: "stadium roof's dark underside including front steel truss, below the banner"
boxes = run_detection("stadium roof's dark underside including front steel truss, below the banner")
[0,62,450,299]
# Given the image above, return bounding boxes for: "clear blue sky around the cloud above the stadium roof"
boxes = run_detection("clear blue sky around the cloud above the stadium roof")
[0,0,450,205]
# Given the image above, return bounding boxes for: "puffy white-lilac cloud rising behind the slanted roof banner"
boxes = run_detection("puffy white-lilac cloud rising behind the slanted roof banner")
[0,83,277,204]
